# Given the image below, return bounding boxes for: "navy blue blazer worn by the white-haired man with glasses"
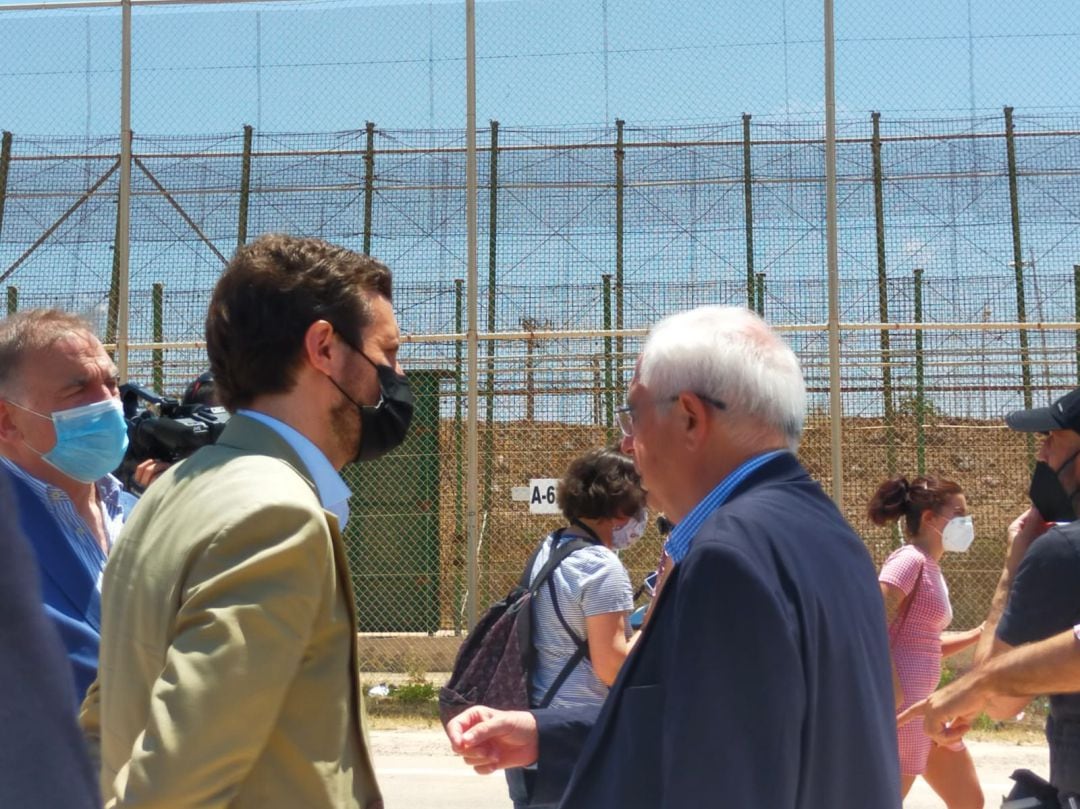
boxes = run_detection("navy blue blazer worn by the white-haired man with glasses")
[532,454,901,809]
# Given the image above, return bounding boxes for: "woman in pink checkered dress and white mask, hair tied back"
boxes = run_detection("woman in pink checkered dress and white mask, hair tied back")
[868,475,983,809]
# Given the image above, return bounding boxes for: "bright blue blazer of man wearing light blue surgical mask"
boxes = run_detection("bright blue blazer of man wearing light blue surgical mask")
[0,466,135,695]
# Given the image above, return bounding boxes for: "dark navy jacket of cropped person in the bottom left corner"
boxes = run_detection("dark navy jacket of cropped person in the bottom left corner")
[0,475,100,809]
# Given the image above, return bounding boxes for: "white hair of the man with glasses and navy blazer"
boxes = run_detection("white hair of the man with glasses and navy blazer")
[638,306,806,450]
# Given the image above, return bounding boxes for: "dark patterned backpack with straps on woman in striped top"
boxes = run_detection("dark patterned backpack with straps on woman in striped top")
[438,528,595,726]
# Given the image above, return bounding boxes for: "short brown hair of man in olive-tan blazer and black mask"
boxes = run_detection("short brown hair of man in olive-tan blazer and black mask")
[206,233,392,410]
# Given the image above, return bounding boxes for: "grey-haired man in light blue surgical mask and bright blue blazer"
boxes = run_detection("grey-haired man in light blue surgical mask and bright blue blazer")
[0,309,135,707]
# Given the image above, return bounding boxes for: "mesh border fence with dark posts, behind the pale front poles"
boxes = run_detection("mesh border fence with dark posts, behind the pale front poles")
[0,109,1080,668]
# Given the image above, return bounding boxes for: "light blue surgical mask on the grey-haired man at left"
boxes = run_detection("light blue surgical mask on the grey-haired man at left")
[12,399,127,483]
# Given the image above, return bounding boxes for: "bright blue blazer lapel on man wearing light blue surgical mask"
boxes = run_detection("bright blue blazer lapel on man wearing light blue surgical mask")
[0,468,102,631]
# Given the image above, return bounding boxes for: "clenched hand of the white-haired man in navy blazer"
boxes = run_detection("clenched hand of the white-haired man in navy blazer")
[446,705,540,776]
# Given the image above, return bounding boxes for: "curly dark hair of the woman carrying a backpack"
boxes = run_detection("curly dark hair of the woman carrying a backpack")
[555,447,645,520]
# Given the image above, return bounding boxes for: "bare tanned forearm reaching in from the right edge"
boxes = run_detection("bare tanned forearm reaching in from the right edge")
[973,629,1080,697]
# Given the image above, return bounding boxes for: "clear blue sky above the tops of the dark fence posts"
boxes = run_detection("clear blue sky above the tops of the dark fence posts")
[0,0,1080,136]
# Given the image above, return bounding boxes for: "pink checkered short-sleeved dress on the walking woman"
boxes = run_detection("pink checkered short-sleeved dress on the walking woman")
[878,545,953,776]
